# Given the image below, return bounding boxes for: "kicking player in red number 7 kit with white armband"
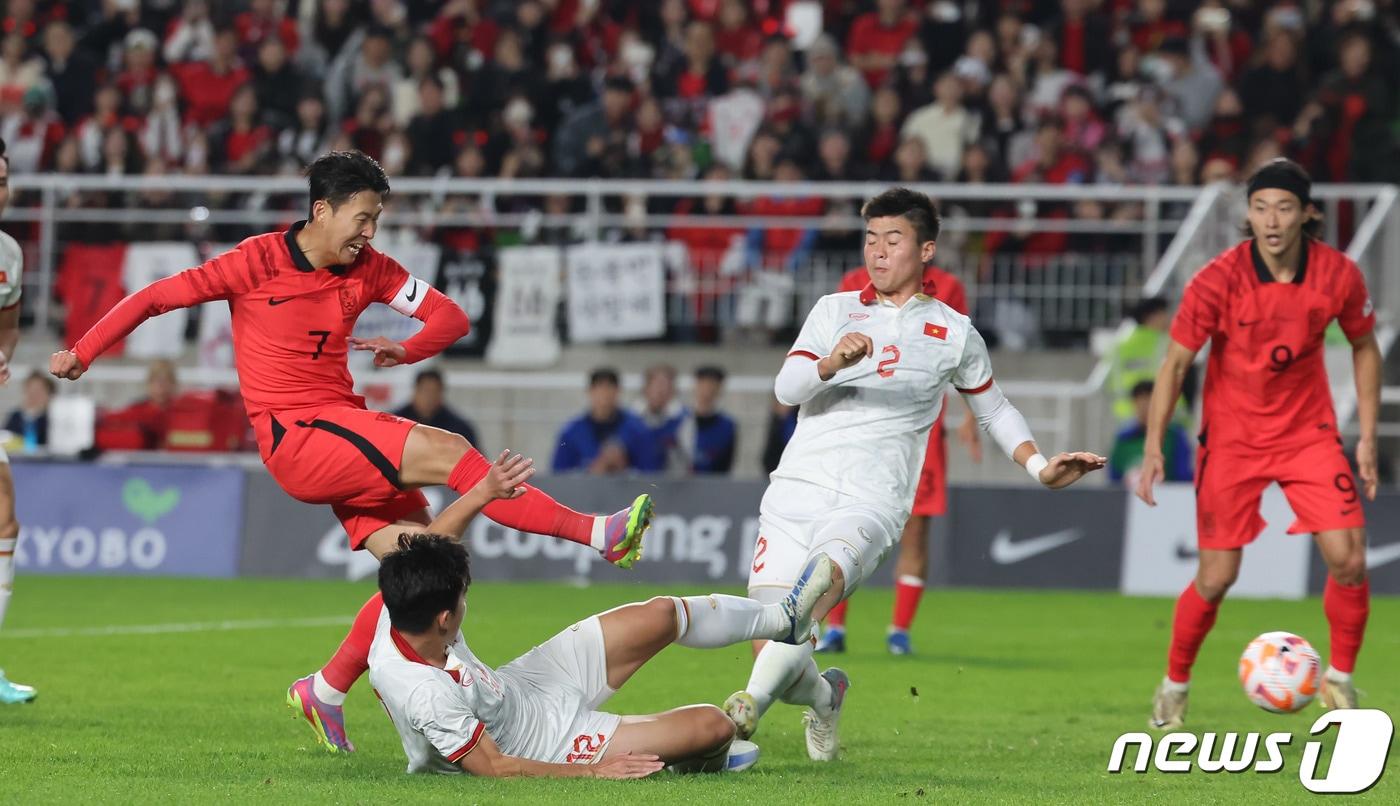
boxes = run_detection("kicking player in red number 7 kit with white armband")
[49,151,652,751]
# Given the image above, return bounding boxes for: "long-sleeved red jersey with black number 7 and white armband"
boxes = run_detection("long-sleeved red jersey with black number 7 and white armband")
[73,221,469,459]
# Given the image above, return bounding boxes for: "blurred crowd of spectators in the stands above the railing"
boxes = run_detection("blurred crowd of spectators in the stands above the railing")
[0,0,1400,201]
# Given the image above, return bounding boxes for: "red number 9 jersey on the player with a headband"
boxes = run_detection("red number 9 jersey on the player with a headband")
[1172,238,1376,455]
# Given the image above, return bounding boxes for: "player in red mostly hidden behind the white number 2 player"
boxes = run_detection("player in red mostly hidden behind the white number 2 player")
[816,266,981,655]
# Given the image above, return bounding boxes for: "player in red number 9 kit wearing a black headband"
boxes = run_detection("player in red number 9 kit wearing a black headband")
[1137,160,1380,730]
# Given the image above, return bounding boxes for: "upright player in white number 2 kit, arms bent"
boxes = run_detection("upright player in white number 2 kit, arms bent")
[724,188,1105,761]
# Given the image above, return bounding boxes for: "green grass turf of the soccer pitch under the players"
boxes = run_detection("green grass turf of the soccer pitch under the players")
[0,577,1400,805]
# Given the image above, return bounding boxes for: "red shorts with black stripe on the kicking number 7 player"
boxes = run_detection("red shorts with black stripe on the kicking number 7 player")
[267,406,428,550]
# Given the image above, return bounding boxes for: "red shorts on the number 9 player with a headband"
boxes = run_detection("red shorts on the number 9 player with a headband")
[1196,442,1366,550]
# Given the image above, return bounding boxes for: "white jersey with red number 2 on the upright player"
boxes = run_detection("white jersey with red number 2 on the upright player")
[773,288,991,516]
